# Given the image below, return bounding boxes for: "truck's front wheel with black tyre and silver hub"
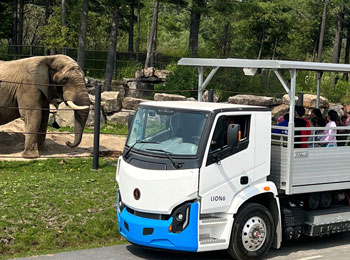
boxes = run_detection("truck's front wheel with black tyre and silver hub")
[228,203,274,260]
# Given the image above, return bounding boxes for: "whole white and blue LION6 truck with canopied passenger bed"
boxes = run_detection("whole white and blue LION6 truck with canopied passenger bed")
[116,58,350,260]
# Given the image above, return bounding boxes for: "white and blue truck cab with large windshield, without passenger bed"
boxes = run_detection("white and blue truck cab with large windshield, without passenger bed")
[117,101,279,256]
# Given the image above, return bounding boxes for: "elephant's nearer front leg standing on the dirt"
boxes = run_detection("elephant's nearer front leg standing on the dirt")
[22,110,42,158]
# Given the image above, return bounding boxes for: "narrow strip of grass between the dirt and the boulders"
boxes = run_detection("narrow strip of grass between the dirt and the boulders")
[47,123,128,135]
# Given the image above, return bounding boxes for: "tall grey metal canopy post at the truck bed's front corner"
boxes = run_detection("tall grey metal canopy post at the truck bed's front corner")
[286,69,297,194]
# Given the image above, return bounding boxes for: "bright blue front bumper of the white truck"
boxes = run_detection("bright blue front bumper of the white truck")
[117,202,199,252]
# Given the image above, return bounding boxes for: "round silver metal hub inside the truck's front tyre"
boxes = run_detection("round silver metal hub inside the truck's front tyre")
[242,217,266,252]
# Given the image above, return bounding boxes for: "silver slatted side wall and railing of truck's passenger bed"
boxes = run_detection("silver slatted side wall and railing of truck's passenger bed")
[269,126,350,194]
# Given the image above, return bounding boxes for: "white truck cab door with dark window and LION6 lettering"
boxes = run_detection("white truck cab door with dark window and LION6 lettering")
[199,114,255,213]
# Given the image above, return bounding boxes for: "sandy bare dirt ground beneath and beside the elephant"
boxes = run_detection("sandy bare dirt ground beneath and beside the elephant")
[0,119,126,160]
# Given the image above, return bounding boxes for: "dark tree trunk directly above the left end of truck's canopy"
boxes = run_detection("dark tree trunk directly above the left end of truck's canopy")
[188,0,205,57]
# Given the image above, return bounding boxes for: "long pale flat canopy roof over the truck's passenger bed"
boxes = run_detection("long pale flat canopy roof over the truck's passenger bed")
[178,58,350,72]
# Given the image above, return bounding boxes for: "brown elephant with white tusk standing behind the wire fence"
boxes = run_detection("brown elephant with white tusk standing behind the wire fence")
[0,55,90,158]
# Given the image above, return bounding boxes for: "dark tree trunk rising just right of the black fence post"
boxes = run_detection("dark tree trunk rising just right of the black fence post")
[104,5,119,91]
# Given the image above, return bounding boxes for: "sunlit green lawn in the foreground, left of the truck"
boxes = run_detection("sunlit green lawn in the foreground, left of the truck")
[0,159,124,259]
